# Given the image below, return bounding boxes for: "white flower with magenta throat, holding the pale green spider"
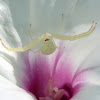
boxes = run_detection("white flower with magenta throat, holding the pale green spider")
[0,0,100,100]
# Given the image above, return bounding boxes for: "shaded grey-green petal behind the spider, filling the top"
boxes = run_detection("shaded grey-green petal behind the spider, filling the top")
[8,0,100,38]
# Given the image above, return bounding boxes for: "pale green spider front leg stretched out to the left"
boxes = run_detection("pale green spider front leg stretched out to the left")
[0,38,41,52]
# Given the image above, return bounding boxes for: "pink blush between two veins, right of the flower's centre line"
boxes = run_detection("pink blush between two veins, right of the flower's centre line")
[53,56,73,88]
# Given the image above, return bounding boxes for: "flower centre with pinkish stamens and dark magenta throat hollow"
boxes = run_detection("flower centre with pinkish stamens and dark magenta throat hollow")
[28,79,73,100]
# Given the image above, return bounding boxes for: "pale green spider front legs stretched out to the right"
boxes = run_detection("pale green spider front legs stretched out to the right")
[51,21,97,41]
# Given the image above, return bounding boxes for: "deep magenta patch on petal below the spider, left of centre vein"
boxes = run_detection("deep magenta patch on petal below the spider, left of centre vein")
[24,54,52,98]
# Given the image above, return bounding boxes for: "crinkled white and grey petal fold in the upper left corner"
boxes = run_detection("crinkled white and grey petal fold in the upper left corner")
[0,0,21,46]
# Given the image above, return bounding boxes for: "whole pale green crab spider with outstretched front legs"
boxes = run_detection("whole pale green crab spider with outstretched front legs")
[0,21,96,55]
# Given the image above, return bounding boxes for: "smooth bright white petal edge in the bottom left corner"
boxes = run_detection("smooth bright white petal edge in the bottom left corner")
[0,75,36,100]
